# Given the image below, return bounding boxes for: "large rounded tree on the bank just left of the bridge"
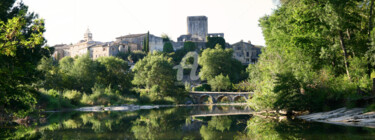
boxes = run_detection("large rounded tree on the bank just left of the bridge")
[132,53,176,97]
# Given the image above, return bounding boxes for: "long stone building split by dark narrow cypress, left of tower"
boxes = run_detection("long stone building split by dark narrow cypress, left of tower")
[115,33,164,52]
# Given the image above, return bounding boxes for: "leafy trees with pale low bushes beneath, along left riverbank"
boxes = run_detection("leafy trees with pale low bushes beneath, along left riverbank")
[38,55,136,109]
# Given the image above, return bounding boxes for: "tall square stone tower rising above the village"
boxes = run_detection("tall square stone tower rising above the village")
[187,16,208,41]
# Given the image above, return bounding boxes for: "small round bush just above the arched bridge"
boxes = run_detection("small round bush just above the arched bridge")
[208,74,232,91]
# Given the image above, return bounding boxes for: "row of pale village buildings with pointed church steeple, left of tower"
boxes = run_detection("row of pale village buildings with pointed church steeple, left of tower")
[52,29,160,60]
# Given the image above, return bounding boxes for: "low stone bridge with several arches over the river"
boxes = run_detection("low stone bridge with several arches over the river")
[189,91,254,104]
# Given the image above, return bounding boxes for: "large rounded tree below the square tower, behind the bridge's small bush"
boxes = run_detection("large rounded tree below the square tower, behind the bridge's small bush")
[198,45,242,82]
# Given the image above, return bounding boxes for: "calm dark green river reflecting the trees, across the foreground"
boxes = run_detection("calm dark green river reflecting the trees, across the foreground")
[0,106,375,140]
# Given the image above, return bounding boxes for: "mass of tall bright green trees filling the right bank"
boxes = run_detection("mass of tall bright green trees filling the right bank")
[248,0,374,111]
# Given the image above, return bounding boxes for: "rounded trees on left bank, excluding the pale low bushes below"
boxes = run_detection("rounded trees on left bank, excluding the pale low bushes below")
[38,55,132,93]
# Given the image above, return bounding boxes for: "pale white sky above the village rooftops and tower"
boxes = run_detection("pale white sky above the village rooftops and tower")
[23,0,277,45]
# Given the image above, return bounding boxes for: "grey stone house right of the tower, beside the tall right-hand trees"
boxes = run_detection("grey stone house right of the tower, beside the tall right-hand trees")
[231,40,262,65]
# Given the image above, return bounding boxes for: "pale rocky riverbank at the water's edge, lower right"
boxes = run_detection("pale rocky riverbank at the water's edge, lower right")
[297,108,375,128]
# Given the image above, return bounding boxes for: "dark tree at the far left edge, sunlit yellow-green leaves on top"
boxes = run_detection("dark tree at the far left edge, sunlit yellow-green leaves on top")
[0,0,51,115]
